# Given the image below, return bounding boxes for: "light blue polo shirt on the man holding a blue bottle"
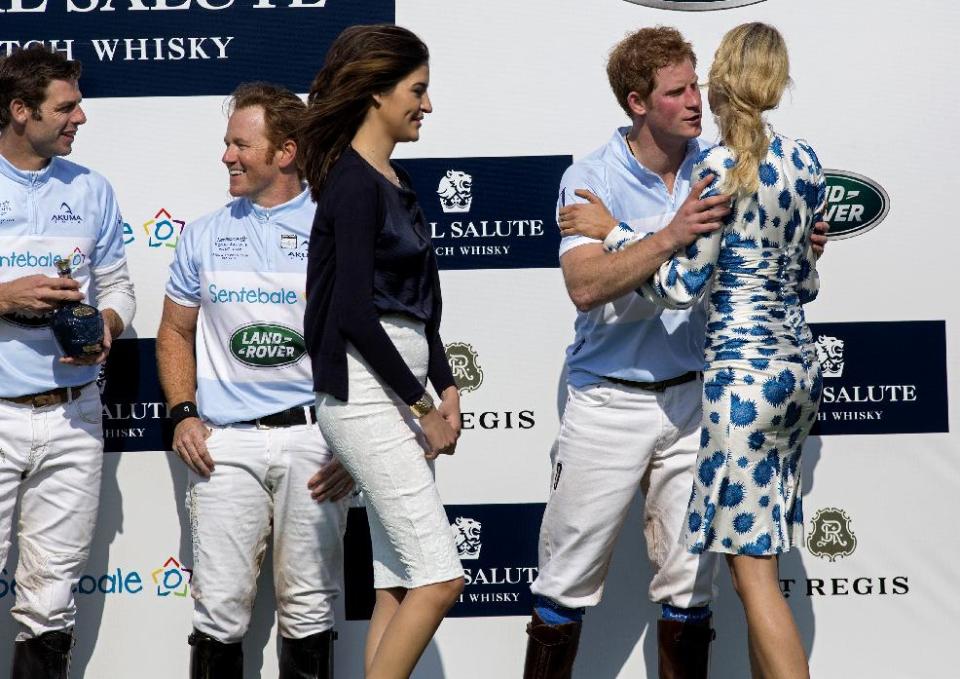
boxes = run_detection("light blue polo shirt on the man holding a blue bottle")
[0,155,126,397]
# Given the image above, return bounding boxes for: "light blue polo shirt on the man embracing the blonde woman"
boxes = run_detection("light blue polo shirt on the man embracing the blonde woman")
[557,127,710,388]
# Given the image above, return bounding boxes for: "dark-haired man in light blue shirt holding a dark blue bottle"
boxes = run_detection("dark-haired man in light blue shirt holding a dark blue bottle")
[0,46,135,679]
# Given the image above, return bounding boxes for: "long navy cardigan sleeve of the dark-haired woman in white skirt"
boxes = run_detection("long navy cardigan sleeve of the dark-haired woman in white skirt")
[329,175,428,405]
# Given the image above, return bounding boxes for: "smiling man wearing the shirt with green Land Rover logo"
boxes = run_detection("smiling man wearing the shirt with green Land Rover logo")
[157,83,352,679]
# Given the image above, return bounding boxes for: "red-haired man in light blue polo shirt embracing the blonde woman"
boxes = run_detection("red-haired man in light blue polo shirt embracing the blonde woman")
[525,28,728,679]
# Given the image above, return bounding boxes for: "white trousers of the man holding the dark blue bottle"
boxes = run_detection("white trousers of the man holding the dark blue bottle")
[0,384,103,640]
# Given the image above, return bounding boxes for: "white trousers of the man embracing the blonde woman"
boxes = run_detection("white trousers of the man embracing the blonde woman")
[531,380,716,608]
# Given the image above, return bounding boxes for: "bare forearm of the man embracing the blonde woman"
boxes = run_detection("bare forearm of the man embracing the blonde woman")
[560,232,676,311]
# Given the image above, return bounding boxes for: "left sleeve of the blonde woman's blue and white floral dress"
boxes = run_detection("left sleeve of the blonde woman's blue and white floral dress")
[640,147,736,309]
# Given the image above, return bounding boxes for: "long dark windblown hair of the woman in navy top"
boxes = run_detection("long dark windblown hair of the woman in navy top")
[300,24,430,200]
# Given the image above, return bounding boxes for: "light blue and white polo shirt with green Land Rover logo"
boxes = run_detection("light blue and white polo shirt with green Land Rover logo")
[166,191,316,425]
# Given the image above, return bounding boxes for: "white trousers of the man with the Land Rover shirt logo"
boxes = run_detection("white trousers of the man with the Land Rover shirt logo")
[187,424,347,643]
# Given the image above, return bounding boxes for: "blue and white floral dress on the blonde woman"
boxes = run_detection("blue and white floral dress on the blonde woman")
[607,134,826,555]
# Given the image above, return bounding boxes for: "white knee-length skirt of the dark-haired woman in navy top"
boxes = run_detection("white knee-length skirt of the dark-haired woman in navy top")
[317,316,463,589]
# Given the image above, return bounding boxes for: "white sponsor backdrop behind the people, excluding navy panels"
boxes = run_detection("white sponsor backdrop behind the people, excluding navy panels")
[0,0,960,679]
